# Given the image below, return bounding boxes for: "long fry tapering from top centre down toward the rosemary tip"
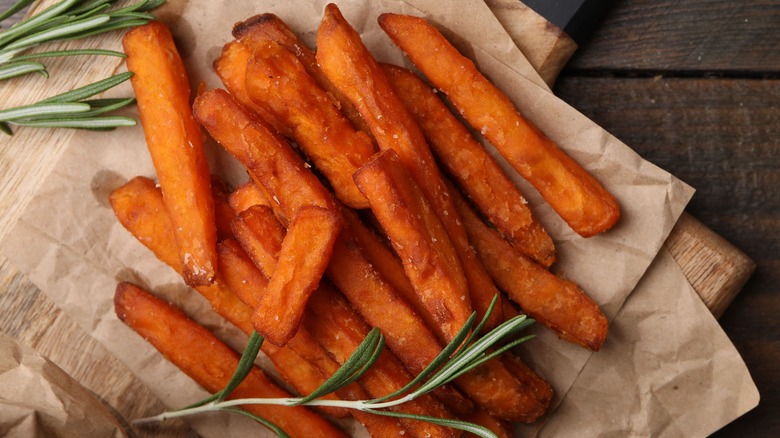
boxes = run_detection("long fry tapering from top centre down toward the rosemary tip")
[317,4,500,328]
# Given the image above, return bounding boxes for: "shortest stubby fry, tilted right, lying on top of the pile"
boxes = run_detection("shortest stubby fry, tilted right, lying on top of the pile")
[252,206,342,346]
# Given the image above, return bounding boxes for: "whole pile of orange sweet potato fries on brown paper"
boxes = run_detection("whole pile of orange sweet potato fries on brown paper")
[111,5,620,437]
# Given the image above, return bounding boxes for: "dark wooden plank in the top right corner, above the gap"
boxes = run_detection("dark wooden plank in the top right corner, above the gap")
[567,0,780,73]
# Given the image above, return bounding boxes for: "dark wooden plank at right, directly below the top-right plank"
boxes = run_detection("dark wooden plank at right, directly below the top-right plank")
[556,75,780,260]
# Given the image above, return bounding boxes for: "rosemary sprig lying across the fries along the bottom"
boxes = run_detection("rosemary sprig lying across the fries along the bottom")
[133,297,534,438]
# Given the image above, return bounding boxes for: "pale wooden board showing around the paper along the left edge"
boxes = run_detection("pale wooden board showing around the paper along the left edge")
[0,0,196,437]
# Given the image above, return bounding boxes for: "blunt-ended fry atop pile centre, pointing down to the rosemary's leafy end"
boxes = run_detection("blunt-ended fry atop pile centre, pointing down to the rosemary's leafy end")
[355,149,472,342]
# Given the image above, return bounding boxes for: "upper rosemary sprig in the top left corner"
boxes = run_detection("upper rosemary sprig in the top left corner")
[0,0,165,80]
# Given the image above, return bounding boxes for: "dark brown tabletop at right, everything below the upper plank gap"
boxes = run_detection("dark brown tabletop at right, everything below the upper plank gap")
[555,74,780,437]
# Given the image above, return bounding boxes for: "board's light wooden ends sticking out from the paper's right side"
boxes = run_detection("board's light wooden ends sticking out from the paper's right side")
[487,0,756,318]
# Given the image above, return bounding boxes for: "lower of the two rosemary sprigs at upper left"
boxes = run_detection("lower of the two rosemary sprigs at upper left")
[0,72,136,135]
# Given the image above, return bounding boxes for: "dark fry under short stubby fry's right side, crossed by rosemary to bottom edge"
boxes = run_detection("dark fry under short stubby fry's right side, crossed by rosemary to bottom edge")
[304,286,458,437]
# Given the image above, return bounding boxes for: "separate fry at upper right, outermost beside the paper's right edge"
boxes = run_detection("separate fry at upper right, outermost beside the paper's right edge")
[379,13,620,237]
